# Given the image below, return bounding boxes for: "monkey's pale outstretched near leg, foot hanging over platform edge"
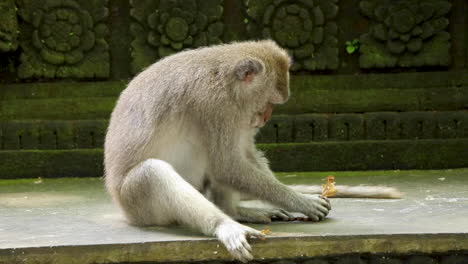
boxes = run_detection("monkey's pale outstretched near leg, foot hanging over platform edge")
[120,159,264,262]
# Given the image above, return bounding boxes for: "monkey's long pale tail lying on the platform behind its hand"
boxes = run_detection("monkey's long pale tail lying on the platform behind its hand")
[289,185,403,199]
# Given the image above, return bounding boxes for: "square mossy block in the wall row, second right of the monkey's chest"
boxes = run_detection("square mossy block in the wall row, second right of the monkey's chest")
[295,114,328,142]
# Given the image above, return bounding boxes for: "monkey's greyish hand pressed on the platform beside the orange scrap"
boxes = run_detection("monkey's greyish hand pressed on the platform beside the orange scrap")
[296,194,331,222]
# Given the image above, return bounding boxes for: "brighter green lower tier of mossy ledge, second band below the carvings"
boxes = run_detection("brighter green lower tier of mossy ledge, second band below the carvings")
[0,87,468,120]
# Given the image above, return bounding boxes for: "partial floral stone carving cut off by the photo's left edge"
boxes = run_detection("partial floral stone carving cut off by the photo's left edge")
[0,0,18,52]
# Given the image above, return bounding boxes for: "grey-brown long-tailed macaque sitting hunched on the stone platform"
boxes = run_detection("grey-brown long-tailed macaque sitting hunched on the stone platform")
[105,40,402,261]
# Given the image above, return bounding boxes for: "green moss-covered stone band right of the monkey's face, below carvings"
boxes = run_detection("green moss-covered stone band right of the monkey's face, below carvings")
[275,73,468,114]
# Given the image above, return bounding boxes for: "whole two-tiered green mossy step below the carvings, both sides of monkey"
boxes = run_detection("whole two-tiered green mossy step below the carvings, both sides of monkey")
[0,72,468,120]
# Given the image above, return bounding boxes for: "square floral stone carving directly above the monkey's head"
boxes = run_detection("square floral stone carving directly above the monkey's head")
[245,0,339,70]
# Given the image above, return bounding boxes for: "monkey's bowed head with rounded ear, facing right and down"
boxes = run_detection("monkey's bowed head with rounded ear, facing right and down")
[234,40,291,128]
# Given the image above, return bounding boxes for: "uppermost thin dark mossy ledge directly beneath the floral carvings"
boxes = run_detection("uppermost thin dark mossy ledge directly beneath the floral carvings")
[0,71,468,100]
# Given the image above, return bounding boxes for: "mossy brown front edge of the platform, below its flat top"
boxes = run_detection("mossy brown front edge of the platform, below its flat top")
[0,233,468,264]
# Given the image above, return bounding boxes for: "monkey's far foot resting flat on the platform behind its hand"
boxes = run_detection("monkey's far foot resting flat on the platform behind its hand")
[234,207,295,224]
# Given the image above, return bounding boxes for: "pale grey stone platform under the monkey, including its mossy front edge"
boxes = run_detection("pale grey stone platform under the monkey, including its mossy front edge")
[0,169,468,264]
